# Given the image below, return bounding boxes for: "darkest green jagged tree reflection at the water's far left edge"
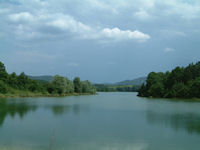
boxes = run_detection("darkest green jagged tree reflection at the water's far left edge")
[0,99,37,126]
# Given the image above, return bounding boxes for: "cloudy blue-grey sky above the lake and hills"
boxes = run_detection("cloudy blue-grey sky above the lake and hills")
[0,0,200,83]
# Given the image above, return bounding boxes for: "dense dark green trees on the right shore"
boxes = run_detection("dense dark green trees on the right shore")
[138,62,200,98]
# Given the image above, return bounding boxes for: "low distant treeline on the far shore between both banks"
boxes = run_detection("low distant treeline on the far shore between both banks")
[95,84,139,92]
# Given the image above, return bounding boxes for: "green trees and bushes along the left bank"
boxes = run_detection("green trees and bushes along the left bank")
[0,62,96,95]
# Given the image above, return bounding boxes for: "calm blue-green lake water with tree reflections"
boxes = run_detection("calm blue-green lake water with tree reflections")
[0,93,200,150]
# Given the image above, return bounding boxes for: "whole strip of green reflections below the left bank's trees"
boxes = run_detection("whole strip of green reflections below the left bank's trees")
[0,98,89,126]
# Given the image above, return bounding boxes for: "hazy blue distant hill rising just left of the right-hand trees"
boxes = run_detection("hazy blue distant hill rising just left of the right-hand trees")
[114,77,147,86]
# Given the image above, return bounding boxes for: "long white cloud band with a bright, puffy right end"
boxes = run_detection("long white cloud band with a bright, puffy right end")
[9,12,150,42]
